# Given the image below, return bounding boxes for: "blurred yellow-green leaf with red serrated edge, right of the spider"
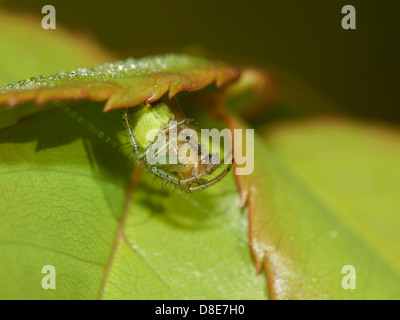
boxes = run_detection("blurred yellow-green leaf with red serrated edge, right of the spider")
[232,115,400,299]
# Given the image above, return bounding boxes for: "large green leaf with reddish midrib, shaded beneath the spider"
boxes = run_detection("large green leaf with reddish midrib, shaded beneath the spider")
[0,102,266,299]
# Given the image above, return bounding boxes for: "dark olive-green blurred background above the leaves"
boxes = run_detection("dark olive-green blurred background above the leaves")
[0,0,400,123]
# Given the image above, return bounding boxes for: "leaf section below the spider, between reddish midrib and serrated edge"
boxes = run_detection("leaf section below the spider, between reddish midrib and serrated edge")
[103,154,266,299]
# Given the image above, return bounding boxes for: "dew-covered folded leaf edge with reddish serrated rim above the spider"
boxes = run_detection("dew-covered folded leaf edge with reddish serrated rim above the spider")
[0,54,239,111]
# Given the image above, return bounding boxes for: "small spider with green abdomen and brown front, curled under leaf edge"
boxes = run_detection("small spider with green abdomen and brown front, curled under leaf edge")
[123,102,233,192]
